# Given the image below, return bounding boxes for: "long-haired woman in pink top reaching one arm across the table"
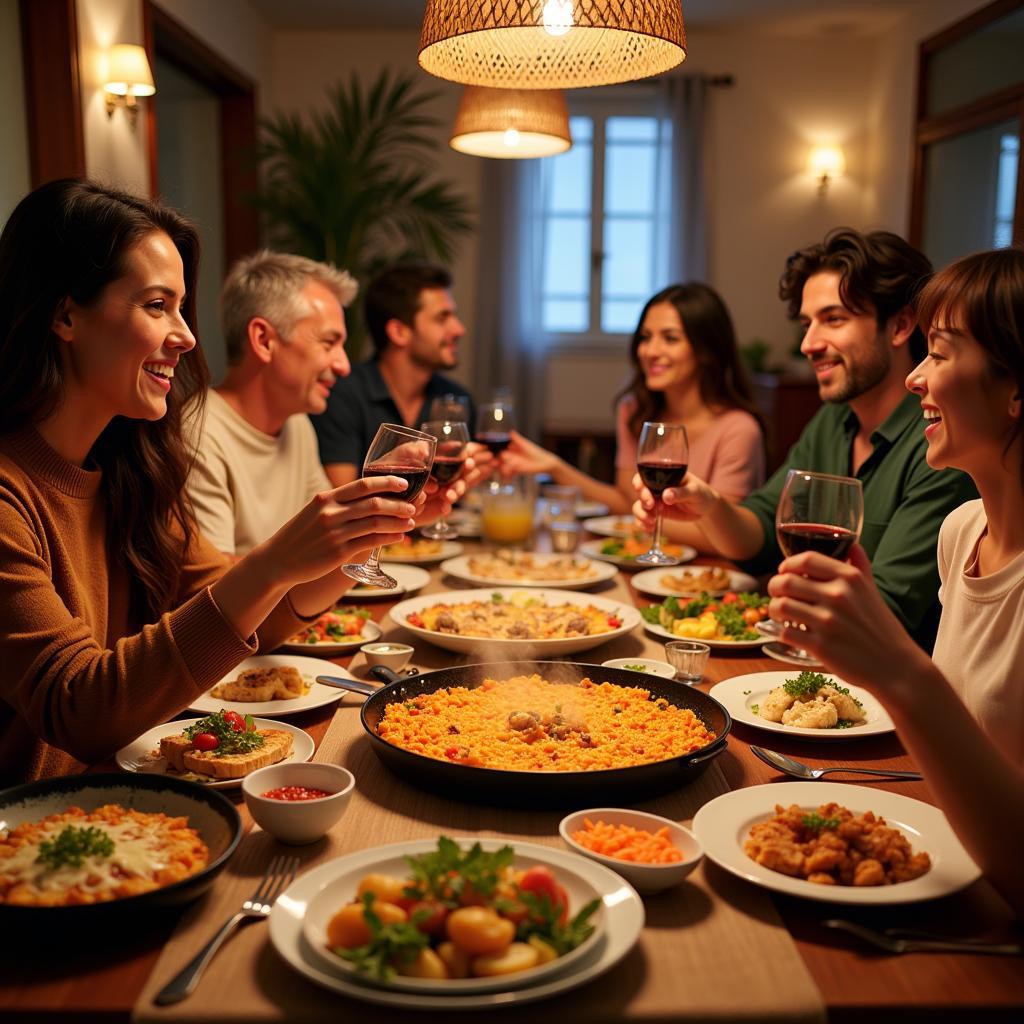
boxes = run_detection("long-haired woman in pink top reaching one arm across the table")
[502,283,765,513]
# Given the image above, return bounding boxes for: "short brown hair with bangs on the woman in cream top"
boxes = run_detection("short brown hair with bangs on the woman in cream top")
[916,248,1024,485]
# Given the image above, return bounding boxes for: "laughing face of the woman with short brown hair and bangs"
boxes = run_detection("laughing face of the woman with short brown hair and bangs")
[906,325,1020,474]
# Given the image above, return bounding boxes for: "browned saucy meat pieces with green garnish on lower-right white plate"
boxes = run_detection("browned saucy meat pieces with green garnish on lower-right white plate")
[743,804,932,886]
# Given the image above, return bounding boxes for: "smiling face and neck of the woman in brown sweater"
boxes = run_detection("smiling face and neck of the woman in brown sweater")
[53,230,196,421]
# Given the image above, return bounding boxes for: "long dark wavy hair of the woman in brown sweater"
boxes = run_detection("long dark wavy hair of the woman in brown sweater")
[0,178,209,617]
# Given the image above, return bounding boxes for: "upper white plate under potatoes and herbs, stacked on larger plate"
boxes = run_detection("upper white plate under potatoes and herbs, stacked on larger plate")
[302,839,607,996]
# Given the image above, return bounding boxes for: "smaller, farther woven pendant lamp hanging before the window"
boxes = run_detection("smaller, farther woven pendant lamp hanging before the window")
[449,85,572,160]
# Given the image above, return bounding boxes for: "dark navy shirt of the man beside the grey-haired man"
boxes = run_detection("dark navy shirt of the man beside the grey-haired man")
[310,359,474,470]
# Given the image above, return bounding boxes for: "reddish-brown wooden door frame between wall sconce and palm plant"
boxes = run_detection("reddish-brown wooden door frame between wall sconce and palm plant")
[142,0,260,271]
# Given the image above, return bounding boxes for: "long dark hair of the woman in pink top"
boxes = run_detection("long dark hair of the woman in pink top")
[615,282,764,437]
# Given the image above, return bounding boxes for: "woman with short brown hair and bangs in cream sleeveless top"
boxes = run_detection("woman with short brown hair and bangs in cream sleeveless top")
[768,249,1024,915]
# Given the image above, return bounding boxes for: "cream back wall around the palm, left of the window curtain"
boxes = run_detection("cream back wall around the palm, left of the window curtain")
[267,32,485,383]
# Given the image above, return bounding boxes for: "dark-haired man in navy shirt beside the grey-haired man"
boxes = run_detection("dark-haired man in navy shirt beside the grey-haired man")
[312,264,473,487]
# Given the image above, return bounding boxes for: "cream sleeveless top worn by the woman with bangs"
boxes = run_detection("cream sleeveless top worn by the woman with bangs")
[932,501,1024,766]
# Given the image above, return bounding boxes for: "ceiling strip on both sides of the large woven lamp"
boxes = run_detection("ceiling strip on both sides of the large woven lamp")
[249,0,928,35]
